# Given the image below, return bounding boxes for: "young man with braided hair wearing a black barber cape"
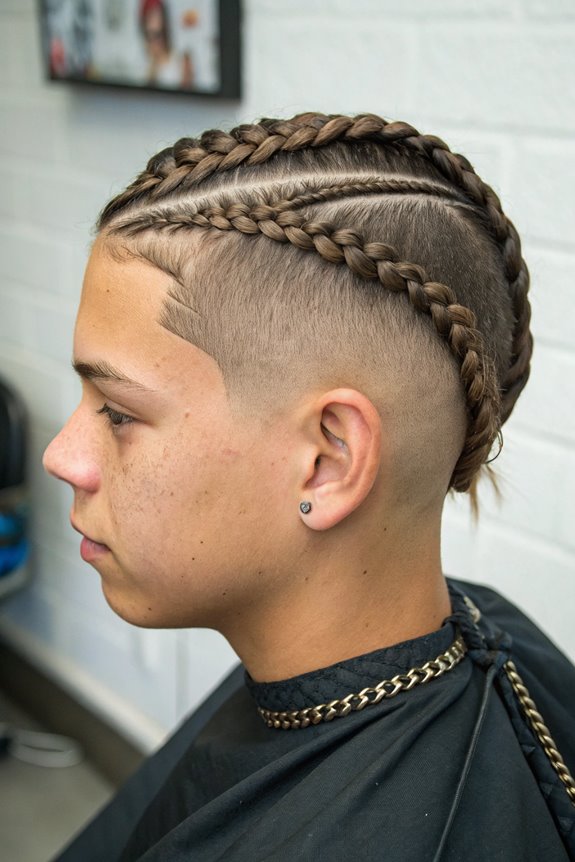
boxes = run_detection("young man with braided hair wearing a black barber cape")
[45,114,575,862]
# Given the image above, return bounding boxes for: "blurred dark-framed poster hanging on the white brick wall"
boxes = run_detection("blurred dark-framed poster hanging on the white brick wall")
[39,0,240,98]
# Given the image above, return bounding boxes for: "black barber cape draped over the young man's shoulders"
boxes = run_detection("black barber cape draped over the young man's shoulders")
[53,581,575,862]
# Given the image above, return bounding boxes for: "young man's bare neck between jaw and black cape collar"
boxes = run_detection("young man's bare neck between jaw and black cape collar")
[220,520,451,682]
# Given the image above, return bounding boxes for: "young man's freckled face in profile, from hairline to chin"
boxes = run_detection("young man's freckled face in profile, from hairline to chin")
[44,240,297,627]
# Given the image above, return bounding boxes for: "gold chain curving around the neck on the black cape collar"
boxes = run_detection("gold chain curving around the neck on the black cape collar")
[258,634,467,730]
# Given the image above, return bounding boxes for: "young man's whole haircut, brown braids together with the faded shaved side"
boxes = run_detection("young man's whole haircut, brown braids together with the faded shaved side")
[94,114,531,506]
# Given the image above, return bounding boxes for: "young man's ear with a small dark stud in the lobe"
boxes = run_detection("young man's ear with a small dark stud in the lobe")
[300,389,382,530]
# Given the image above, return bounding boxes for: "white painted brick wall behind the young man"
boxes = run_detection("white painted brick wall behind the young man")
[0,0,575,745]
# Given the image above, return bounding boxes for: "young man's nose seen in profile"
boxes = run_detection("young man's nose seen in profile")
[42,405,100,493]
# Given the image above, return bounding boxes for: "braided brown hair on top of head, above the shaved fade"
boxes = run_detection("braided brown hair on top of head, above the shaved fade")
[98,113,532,491]
